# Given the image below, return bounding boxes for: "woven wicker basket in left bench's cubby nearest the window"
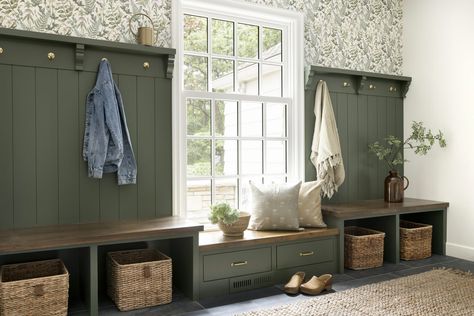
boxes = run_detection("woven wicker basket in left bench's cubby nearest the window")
[107,249,172,311]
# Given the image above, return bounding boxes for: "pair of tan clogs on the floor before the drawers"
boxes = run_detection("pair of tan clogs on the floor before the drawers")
[284,272,332,295]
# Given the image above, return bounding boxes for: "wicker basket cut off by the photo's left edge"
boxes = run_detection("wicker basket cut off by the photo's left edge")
[0,259,69,316]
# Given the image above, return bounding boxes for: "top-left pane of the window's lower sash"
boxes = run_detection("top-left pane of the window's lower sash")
[186,99,211,136]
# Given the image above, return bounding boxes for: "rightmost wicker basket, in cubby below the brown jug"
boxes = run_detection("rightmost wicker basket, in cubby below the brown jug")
[400,220,433,260]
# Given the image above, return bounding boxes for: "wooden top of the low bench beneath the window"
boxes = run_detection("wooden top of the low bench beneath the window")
[199,228,339,251]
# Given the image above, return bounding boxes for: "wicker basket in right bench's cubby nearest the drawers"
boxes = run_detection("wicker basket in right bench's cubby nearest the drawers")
[344,226,385,270]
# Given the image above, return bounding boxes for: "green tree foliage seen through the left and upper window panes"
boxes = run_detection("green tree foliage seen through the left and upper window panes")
[183,15,282,176]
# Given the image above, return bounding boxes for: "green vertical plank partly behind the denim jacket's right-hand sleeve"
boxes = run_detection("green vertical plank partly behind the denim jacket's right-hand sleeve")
[117,75,140,219]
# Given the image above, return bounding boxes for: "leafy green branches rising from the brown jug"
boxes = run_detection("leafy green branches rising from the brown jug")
[369,121,446,170]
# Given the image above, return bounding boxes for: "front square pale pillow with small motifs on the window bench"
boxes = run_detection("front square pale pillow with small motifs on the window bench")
[249,182,301,230]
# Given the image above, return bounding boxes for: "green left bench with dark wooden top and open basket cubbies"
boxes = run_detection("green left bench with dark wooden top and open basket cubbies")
[0,217,203,315]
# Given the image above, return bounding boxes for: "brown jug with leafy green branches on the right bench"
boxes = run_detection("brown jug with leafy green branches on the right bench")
[369,121,446,202]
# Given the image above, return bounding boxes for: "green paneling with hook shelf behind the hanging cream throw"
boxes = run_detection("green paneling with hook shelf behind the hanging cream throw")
[305,66,411,203]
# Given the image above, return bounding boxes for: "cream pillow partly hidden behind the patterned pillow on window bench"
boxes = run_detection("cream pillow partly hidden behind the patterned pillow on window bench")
[298,181,327,227]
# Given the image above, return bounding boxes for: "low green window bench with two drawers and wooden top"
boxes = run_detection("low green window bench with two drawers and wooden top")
[199,228,339,299]
